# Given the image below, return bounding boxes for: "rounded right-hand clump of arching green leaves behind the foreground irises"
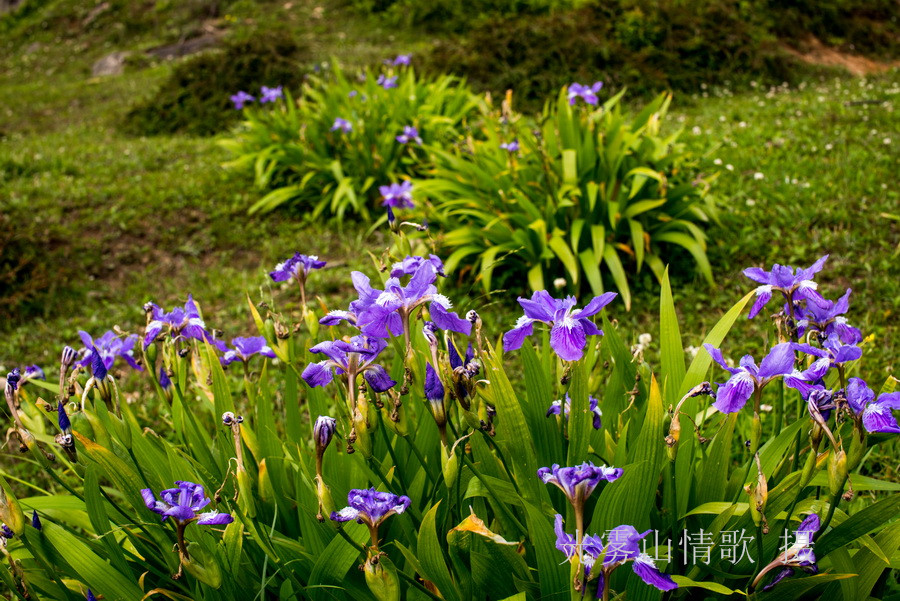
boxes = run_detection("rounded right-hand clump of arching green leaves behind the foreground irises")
[416,89,715,307]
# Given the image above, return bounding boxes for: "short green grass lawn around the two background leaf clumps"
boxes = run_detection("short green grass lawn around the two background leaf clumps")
[0,3,900,387]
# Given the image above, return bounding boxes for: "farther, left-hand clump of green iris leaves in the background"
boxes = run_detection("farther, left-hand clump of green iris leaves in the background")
[225,65,478,217]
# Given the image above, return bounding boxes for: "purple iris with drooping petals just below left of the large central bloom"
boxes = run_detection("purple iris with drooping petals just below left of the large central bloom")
[301,336,397,392]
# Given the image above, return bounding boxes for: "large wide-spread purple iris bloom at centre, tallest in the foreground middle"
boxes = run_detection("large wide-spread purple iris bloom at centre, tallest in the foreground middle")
[357,263,472,337]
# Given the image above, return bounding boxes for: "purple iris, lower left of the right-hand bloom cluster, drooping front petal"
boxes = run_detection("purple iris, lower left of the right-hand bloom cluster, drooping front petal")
[703,342,794,413]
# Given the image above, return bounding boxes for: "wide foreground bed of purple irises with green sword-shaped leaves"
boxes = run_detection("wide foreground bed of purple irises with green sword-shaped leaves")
[0,223,900,600]
